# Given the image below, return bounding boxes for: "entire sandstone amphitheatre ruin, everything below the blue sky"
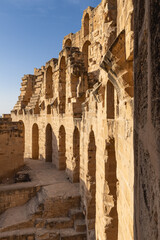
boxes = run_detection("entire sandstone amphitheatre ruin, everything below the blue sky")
[0,0,160,240]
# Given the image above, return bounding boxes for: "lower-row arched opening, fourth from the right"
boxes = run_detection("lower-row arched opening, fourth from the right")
[59,126,66,170]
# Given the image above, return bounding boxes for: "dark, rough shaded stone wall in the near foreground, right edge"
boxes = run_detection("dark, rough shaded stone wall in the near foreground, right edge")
[134,0,160,240]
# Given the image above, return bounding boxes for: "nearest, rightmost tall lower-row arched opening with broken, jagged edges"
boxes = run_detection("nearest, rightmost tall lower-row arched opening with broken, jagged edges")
[104,139,118,240]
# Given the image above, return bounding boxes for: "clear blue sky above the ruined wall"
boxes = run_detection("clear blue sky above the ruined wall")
[0,0,101,115]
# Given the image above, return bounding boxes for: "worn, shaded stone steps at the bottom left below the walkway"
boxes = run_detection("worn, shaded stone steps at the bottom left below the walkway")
[0,187,87,240]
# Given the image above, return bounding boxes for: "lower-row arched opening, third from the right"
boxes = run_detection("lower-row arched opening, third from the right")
[73,127,80,182]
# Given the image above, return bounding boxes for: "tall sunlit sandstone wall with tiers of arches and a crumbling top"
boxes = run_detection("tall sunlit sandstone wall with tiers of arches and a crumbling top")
[12,0,134,240]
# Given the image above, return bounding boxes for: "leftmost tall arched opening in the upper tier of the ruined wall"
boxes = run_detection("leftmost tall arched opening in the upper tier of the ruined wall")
[46,66,53,99]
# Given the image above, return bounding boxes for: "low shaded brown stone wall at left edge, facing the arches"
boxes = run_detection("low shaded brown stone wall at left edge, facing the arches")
[0,118,24,179]
